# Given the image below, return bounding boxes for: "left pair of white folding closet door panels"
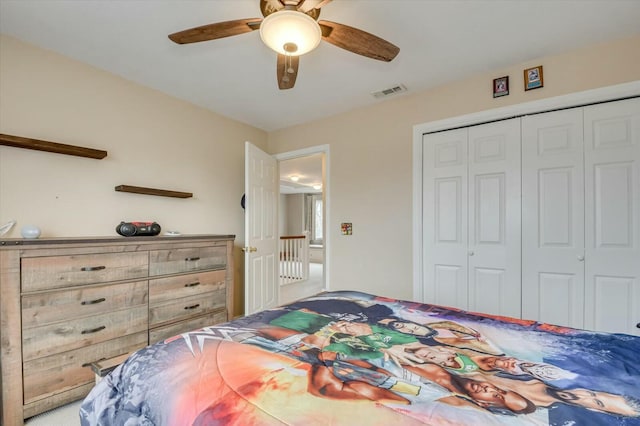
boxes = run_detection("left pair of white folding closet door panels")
[423,119,521,317]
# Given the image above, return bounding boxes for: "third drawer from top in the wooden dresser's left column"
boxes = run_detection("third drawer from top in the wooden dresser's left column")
[22,304,148,361]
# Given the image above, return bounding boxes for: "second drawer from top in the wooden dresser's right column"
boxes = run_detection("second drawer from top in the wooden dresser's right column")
[149,270,227,302]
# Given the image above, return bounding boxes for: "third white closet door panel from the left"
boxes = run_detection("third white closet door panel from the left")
[522,109,584,328]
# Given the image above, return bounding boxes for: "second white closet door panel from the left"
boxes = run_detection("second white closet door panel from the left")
[468,119,521,318]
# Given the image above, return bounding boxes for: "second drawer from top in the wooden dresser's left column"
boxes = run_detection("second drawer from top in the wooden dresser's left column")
[22,281,147,328]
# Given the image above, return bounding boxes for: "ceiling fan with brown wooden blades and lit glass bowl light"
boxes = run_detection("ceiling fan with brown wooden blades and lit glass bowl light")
[169,0,400,90]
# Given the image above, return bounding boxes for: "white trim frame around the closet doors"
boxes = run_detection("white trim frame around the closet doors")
[413,80,640,301]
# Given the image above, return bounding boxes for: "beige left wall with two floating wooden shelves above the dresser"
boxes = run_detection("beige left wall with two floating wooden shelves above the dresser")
[0,36,267,312]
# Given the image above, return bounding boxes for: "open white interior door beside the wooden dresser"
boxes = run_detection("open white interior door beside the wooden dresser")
[243,142,280,315]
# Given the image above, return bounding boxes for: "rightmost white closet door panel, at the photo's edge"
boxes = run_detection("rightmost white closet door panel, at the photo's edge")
[584,99,640,335]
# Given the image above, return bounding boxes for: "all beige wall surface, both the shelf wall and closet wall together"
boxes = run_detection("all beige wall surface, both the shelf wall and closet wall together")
[0,33,640,312]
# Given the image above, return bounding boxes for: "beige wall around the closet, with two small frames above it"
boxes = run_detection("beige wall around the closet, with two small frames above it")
[269,37,640,299]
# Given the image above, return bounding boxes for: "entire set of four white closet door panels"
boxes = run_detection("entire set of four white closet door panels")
[421,97,640,335]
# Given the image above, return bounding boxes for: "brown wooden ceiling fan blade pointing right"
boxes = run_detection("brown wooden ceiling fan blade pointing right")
[318,21,400,62]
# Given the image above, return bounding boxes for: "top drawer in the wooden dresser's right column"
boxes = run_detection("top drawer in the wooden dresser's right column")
[149,246,227,276]
